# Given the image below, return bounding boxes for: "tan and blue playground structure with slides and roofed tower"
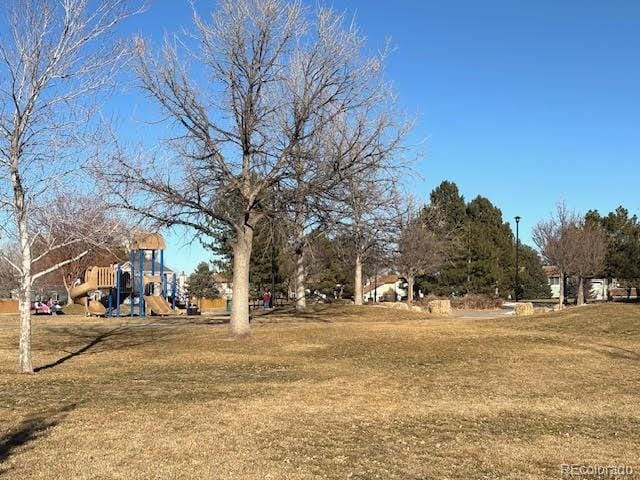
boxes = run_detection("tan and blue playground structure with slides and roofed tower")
[69,233,181,317]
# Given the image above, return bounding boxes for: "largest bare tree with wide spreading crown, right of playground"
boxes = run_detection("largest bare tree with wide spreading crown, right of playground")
[102,0,398,335]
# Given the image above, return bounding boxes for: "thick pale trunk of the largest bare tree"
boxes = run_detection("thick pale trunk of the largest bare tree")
[230,225,253,336]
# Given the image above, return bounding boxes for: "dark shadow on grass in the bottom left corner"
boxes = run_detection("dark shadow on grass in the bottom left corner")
[0,403,77,468]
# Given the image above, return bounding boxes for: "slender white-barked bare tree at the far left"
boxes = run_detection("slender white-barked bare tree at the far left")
[0,0,140,373]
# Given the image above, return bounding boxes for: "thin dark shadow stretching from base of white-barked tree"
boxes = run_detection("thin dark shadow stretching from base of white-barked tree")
[34,325,174,372]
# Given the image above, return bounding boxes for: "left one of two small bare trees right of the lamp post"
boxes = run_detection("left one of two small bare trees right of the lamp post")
[533,203,580,308]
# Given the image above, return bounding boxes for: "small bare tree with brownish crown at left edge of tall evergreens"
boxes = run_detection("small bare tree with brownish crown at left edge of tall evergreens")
[397,207,452,305]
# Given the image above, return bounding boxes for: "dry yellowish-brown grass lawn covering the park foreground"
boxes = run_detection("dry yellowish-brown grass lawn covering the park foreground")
[0,305,640,480]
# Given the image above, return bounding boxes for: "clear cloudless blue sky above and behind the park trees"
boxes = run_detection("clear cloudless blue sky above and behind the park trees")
[116,0,640,271]
